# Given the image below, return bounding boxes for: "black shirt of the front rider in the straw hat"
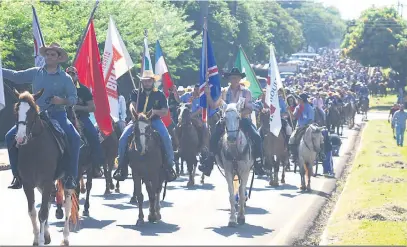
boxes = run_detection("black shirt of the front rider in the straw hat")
[130,89,168,120]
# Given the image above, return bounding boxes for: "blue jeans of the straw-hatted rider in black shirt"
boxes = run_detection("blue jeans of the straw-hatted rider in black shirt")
[117,119,174,168]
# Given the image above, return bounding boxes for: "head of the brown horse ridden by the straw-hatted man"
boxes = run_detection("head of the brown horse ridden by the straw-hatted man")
[134,113,157,155]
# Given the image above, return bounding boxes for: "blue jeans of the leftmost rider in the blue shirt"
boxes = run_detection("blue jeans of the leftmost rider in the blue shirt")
[6,111,81,178]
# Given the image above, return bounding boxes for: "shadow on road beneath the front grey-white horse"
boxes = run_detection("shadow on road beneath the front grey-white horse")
[205,223,273,238]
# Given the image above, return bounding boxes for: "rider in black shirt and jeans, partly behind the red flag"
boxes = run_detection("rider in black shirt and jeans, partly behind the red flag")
[66,67,105,178]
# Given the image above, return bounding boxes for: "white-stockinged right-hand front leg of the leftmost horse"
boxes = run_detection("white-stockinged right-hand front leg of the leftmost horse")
[38,186,52,246]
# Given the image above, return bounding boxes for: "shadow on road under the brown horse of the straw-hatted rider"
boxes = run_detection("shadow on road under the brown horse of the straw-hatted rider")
[117,221,180,236]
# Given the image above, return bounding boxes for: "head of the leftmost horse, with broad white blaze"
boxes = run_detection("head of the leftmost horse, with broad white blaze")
[14,89,44,146]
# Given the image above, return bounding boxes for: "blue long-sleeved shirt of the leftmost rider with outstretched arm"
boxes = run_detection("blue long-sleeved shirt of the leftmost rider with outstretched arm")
[2,66,78,111]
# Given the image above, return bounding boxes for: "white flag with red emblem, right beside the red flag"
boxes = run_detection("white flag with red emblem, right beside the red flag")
[102,17,134,122]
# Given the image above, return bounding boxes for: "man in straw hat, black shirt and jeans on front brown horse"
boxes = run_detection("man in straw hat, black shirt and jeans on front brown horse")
[113,70,177,182]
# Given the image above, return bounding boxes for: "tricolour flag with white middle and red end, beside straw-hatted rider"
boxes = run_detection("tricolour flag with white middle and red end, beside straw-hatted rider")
[155,40,174,127]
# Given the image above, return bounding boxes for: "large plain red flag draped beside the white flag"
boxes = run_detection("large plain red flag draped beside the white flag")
[74,20,113,136]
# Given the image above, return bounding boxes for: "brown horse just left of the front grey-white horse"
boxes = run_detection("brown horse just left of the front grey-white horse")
[177,104,202,187]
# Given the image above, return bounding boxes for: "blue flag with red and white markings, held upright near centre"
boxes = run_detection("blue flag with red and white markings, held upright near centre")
[199,29,221,122]
